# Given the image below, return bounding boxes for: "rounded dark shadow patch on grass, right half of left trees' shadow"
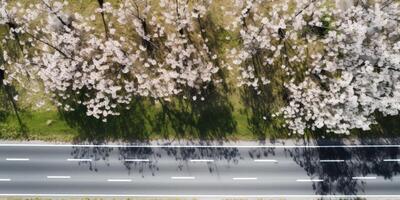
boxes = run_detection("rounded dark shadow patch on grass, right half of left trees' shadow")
[153,86,236,140]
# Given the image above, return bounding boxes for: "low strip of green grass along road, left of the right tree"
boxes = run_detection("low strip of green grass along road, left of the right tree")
[0,98,282,142]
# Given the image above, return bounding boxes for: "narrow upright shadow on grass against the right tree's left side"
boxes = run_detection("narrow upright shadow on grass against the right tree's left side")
[241,52,287,141]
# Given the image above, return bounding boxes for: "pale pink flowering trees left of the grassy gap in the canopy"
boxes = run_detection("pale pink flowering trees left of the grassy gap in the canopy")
[0,0,219,120]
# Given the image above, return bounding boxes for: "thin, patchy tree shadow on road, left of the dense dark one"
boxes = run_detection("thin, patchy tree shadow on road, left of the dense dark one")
[71,146,243,178]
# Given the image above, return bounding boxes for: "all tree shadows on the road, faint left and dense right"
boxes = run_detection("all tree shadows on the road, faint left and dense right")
[66,137,400,188]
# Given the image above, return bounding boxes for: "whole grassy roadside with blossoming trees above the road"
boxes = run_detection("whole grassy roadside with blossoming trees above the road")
[0,0,400,142]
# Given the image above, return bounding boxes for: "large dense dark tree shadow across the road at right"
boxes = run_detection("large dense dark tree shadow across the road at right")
[286,140,400,195]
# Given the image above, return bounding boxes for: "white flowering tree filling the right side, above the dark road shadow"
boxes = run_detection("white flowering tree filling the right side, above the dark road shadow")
[228,0,400,133]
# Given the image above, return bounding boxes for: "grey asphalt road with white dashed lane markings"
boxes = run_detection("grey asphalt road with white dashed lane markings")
[0,145,400,196]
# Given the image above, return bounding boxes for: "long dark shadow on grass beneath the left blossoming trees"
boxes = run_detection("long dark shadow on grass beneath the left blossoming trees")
[59,83,236,144]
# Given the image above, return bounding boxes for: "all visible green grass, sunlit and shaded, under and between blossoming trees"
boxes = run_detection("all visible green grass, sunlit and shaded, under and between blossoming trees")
[0,0,400,142]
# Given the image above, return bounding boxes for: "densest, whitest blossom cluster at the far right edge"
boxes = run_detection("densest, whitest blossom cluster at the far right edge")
[283,3,400,134]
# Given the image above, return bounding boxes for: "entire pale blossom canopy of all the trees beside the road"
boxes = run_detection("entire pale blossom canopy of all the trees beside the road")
[0,0,400,134]
